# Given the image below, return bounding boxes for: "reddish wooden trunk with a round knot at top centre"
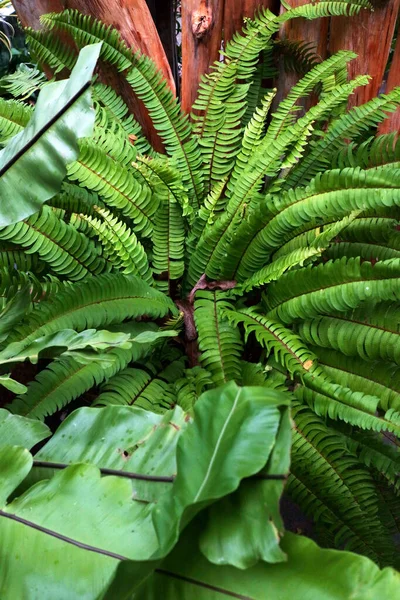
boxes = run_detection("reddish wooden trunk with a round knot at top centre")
[181,0,224,113]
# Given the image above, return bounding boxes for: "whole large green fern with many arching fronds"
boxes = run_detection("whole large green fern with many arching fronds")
[0,1,400,597]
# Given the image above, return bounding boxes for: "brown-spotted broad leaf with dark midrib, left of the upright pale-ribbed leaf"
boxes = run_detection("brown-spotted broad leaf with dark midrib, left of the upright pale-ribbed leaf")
[33,406,188,502]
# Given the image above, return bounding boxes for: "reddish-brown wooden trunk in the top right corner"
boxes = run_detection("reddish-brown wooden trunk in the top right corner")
[329,0,400,106]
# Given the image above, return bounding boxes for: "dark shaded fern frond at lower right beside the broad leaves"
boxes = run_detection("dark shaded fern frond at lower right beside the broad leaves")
[287,405,390,562]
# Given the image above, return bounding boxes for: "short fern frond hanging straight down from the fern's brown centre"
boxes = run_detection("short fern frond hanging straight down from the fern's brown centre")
[194,292,243,385]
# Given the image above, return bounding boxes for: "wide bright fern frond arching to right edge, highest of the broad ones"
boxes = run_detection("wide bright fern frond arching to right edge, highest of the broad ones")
[231,168,400,280]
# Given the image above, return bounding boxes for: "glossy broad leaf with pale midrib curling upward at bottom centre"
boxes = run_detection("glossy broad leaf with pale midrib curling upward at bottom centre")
[154,382,288,552]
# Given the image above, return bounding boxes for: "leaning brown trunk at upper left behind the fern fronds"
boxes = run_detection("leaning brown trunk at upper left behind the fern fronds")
[13,0,175,149]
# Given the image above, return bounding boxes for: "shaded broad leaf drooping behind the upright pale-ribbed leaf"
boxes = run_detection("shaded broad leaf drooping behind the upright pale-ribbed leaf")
[200,404,292,569]
